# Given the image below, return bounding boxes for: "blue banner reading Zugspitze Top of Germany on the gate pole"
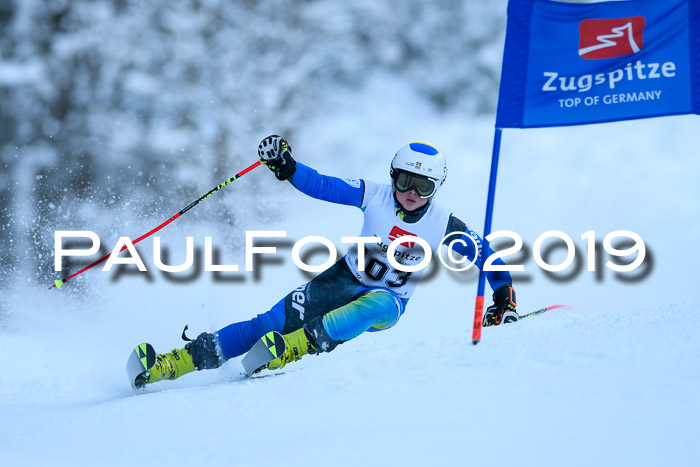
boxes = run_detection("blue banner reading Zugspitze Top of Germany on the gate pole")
[496,0,700,128]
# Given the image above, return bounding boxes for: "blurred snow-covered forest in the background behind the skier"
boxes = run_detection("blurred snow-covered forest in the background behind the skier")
[0,0,506,288]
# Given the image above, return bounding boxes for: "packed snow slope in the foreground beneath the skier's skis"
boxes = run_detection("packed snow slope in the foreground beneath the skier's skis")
[0,298,700,466]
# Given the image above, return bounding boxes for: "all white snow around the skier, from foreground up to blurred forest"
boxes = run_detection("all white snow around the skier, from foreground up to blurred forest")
[0,68,700,466]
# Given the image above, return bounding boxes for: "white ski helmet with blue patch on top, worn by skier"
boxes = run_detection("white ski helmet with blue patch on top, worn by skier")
[390,142,447,198]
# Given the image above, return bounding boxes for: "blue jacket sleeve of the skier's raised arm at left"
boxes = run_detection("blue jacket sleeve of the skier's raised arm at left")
[288,162,365,208]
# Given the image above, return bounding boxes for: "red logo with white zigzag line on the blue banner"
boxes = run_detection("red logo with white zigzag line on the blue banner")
[578,16,646,60]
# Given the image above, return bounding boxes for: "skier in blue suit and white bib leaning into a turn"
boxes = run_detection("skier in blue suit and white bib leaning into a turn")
[137,135,518,385]
